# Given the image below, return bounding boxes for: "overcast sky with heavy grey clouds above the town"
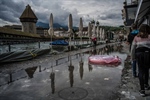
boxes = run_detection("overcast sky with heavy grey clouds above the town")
[0,0,123,26]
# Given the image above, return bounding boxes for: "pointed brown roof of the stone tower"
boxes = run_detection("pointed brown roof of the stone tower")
[20,5,38,20]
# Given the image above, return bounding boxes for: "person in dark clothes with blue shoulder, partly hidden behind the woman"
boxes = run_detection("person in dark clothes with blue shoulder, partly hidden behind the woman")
[127,24,139,77]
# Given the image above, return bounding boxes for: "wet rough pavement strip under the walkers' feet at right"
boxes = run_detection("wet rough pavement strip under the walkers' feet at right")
[119,43,150,100]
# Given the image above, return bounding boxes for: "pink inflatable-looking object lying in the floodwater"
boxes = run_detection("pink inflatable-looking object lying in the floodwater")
[88,55,121,65]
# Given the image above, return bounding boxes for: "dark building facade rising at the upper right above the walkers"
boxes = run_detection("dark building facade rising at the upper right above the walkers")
[122,0,150,33]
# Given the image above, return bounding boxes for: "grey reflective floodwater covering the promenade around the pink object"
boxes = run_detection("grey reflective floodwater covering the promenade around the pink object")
[0,44,127,100]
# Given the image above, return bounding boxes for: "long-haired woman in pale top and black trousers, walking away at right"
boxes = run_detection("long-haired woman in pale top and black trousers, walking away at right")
[131,24,150,96]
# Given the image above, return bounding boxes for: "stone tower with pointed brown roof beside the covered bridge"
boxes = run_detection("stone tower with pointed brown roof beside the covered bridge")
[20,5,38,33]
